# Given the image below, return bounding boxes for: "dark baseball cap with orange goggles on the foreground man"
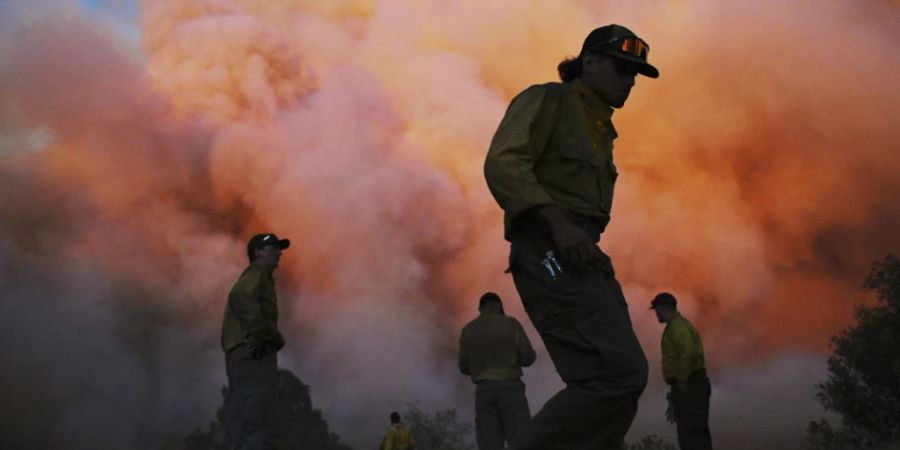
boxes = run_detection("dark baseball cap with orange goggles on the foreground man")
[581,24,659,78]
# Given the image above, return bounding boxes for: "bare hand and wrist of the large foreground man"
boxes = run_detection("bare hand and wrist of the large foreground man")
[534,205,608,271]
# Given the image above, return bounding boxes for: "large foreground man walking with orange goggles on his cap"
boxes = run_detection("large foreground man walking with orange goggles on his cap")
[484,25,659,450]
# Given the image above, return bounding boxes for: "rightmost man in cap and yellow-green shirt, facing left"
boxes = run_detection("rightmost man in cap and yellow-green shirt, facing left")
[650,292,712,450]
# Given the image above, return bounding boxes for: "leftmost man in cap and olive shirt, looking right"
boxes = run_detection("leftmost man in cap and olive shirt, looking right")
[222,233,291,450]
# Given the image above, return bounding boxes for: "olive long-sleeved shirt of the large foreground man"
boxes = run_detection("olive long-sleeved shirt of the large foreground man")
[484,79,618,239]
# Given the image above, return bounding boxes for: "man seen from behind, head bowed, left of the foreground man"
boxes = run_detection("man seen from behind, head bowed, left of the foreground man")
[459,292,535,450]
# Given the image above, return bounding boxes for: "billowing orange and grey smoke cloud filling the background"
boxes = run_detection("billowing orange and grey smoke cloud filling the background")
[0,0,900,448]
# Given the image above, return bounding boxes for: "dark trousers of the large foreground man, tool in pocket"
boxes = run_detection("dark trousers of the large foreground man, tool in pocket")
[510,234,648,450]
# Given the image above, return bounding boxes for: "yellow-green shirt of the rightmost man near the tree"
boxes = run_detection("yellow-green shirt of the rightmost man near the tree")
[662,314,706,383]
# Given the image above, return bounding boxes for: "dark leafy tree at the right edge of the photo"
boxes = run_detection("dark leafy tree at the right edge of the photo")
[807,255,900,450]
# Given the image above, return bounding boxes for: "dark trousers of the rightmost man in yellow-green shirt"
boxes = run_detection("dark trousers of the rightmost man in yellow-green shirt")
[670,370,712,450]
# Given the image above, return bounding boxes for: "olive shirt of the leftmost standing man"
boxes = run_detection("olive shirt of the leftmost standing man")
[222,263,284,353]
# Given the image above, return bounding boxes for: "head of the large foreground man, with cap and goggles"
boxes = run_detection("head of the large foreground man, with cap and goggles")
[557,24,659,108]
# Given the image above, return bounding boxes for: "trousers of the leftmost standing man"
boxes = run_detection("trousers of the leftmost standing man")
[225,345,278,450]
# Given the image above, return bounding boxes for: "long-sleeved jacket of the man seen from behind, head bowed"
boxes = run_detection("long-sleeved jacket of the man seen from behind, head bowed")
[459,314,535,383]
